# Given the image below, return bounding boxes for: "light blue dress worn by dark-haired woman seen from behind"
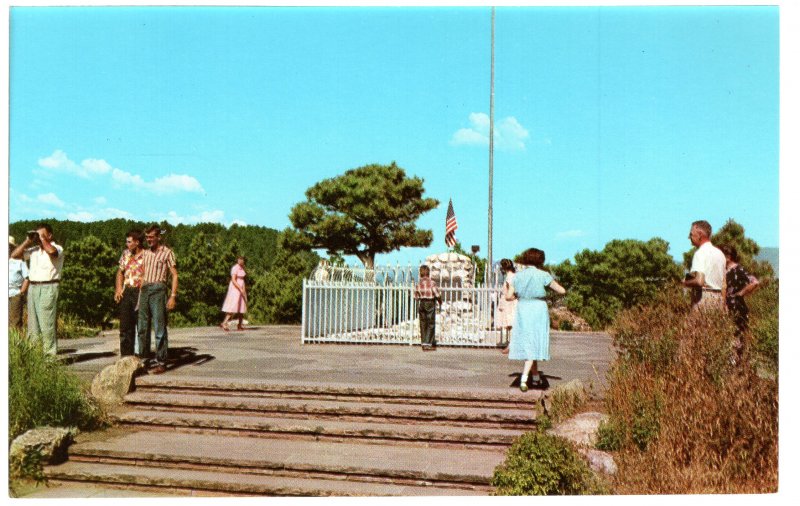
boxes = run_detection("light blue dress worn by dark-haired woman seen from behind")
[508,267,553,360]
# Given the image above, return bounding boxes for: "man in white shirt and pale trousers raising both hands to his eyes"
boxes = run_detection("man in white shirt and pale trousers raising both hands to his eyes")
[11,223,64,355]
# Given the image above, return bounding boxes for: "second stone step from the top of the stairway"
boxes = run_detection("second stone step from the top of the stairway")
[125,390,535,430]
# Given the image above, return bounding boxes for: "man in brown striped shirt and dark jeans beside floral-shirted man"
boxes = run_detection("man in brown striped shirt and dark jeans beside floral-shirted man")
[137,225,178,374]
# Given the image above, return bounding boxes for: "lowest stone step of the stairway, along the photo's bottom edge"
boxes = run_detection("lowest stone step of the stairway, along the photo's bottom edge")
[45,461,487,497]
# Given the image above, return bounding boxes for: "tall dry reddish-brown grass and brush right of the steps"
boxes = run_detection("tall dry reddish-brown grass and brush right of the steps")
[598,285,778,494]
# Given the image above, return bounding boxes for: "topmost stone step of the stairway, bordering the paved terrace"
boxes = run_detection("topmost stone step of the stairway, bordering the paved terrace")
[136,375,542,409]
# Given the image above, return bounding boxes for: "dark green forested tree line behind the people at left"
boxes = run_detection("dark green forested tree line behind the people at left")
[9,219,319,327]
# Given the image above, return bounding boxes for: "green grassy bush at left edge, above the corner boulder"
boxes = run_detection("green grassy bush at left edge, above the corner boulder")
[8,329,103,442]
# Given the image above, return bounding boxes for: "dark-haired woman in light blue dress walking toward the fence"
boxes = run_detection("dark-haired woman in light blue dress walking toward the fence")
[508,248,566,392]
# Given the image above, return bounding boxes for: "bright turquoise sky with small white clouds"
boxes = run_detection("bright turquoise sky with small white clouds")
[8,2,780,264]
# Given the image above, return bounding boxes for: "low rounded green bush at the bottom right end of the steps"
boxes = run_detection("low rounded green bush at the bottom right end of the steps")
[492,431,604,495]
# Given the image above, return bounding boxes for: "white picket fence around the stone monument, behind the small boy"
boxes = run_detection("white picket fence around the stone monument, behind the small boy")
[301,269,501,347]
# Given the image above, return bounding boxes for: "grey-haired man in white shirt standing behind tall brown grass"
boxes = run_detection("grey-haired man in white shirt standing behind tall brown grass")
[683,220,725,309]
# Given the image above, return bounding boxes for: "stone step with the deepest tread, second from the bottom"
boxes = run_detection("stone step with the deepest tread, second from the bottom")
[69,428,505,491]
